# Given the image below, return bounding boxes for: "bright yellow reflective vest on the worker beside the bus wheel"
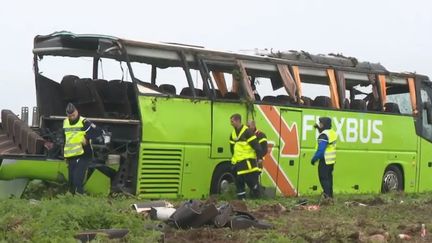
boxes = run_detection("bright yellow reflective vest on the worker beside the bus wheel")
[230,125,256,164]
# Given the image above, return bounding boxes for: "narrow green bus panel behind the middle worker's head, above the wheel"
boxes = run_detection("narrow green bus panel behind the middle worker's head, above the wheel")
[209,101,248,160]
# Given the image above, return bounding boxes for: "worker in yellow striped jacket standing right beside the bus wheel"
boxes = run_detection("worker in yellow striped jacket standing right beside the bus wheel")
[230,114,263,199]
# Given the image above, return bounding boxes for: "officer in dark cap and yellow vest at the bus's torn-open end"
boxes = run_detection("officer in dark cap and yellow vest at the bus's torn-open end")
[63,103,103,194]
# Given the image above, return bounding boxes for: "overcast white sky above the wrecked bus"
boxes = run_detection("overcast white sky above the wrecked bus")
[0,0,432,112]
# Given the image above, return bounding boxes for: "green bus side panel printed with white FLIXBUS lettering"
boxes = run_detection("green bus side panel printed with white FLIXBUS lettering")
[302,109,417,152]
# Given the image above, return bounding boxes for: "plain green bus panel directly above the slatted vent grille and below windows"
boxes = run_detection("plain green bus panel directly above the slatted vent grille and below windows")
[139,96,211,144]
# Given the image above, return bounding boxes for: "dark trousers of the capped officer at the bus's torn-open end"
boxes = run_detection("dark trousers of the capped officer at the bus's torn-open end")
[67,157,90,194]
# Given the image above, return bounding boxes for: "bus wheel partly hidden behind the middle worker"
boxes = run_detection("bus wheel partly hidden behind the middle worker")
[210,162,235,195]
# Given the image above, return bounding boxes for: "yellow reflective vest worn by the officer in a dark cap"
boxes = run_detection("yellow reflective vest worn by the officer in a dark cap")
[63,117,86,158]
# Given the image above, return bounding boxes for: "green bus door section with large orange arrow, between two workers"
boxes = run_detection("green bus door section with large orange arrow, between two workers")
[259,105,302,196]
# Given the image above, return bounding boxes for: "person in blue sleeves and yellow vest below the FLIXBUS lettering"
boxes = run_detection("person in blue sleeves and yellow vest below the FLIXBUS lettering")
[311,117,337,198]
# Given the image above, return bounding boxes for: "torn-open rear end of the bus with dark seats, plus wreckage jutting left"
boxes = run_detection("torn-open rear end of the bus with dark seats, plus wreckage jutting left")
[0,52,140,192]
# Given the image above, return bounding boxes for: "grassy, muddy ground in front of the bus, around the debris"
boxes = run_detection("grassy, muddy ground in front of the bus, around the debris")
[0,181,432,243]
